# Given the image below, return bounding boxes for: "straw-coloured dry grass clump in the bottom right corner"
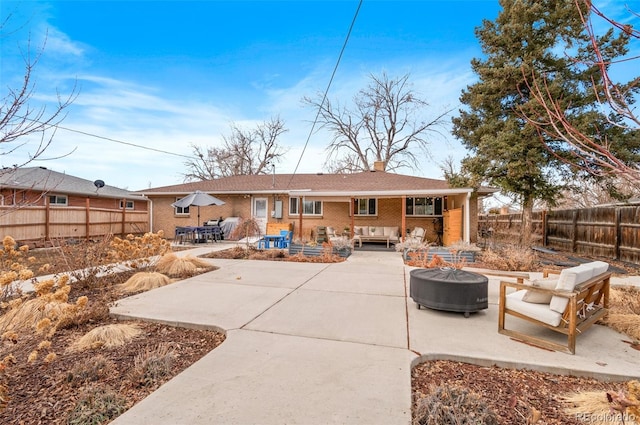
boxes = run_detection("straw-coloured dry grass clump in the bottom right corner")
[562,381,640,425]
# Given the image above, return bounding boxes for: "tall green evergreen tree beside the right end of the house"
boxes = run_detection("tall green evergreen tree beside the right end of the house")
[453,0,626,244]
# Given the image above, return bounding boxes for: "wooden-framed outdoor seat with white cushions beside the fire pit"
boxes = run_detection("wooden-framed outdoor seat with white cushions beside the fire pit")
[498,261,611,354]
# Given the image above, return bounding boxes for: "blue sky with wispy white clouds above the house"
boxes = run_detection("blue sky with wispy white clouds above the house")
[0,0,638,190]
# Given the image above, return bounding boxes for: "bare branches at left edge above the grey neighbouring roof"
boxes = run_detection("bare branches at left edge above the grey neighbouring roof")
[0,15,77,173]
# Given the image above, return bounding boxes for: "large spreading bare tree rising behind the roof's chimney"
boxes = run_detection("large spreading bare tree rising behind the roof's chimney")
[303,73,451,172]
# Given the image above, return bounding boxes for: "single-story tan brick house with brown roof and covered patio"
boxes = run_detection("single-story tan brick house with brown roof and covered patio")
[139,164,497,245]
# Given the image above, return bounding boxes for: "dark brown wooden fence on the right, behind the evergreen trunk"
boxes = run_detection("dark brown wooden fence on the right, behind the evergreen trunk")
[478,205,640,263]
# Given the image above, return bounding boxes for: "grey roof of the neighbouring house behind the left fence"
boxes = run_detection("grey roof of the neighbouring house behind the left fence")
[0,167,145,200]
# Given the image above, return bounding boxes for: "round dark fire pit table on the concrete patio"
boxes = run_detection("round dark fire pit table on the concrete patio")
[409,267,489,317]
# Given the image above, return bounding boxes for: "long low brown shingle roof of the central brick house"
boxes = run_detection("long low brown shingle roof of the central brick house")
[139,171,498,197]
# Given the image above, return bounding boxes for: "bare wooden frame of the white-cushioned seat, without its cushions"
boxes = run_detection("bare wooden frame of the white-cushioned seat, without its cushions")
[498,270,611,354]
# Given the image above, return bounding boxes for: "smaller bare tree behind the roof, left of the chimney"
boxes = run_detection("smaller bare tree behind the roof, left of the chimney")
[184,117,288,181]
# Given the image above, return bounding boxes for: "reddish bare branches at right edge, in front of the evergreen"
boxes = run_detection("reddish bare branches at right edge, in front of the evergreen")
[524,0,640,188]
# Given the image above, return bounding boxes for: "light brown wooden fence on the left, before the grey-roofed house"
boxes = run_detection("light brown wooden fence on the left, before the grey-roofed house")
[0,206,149,245]
